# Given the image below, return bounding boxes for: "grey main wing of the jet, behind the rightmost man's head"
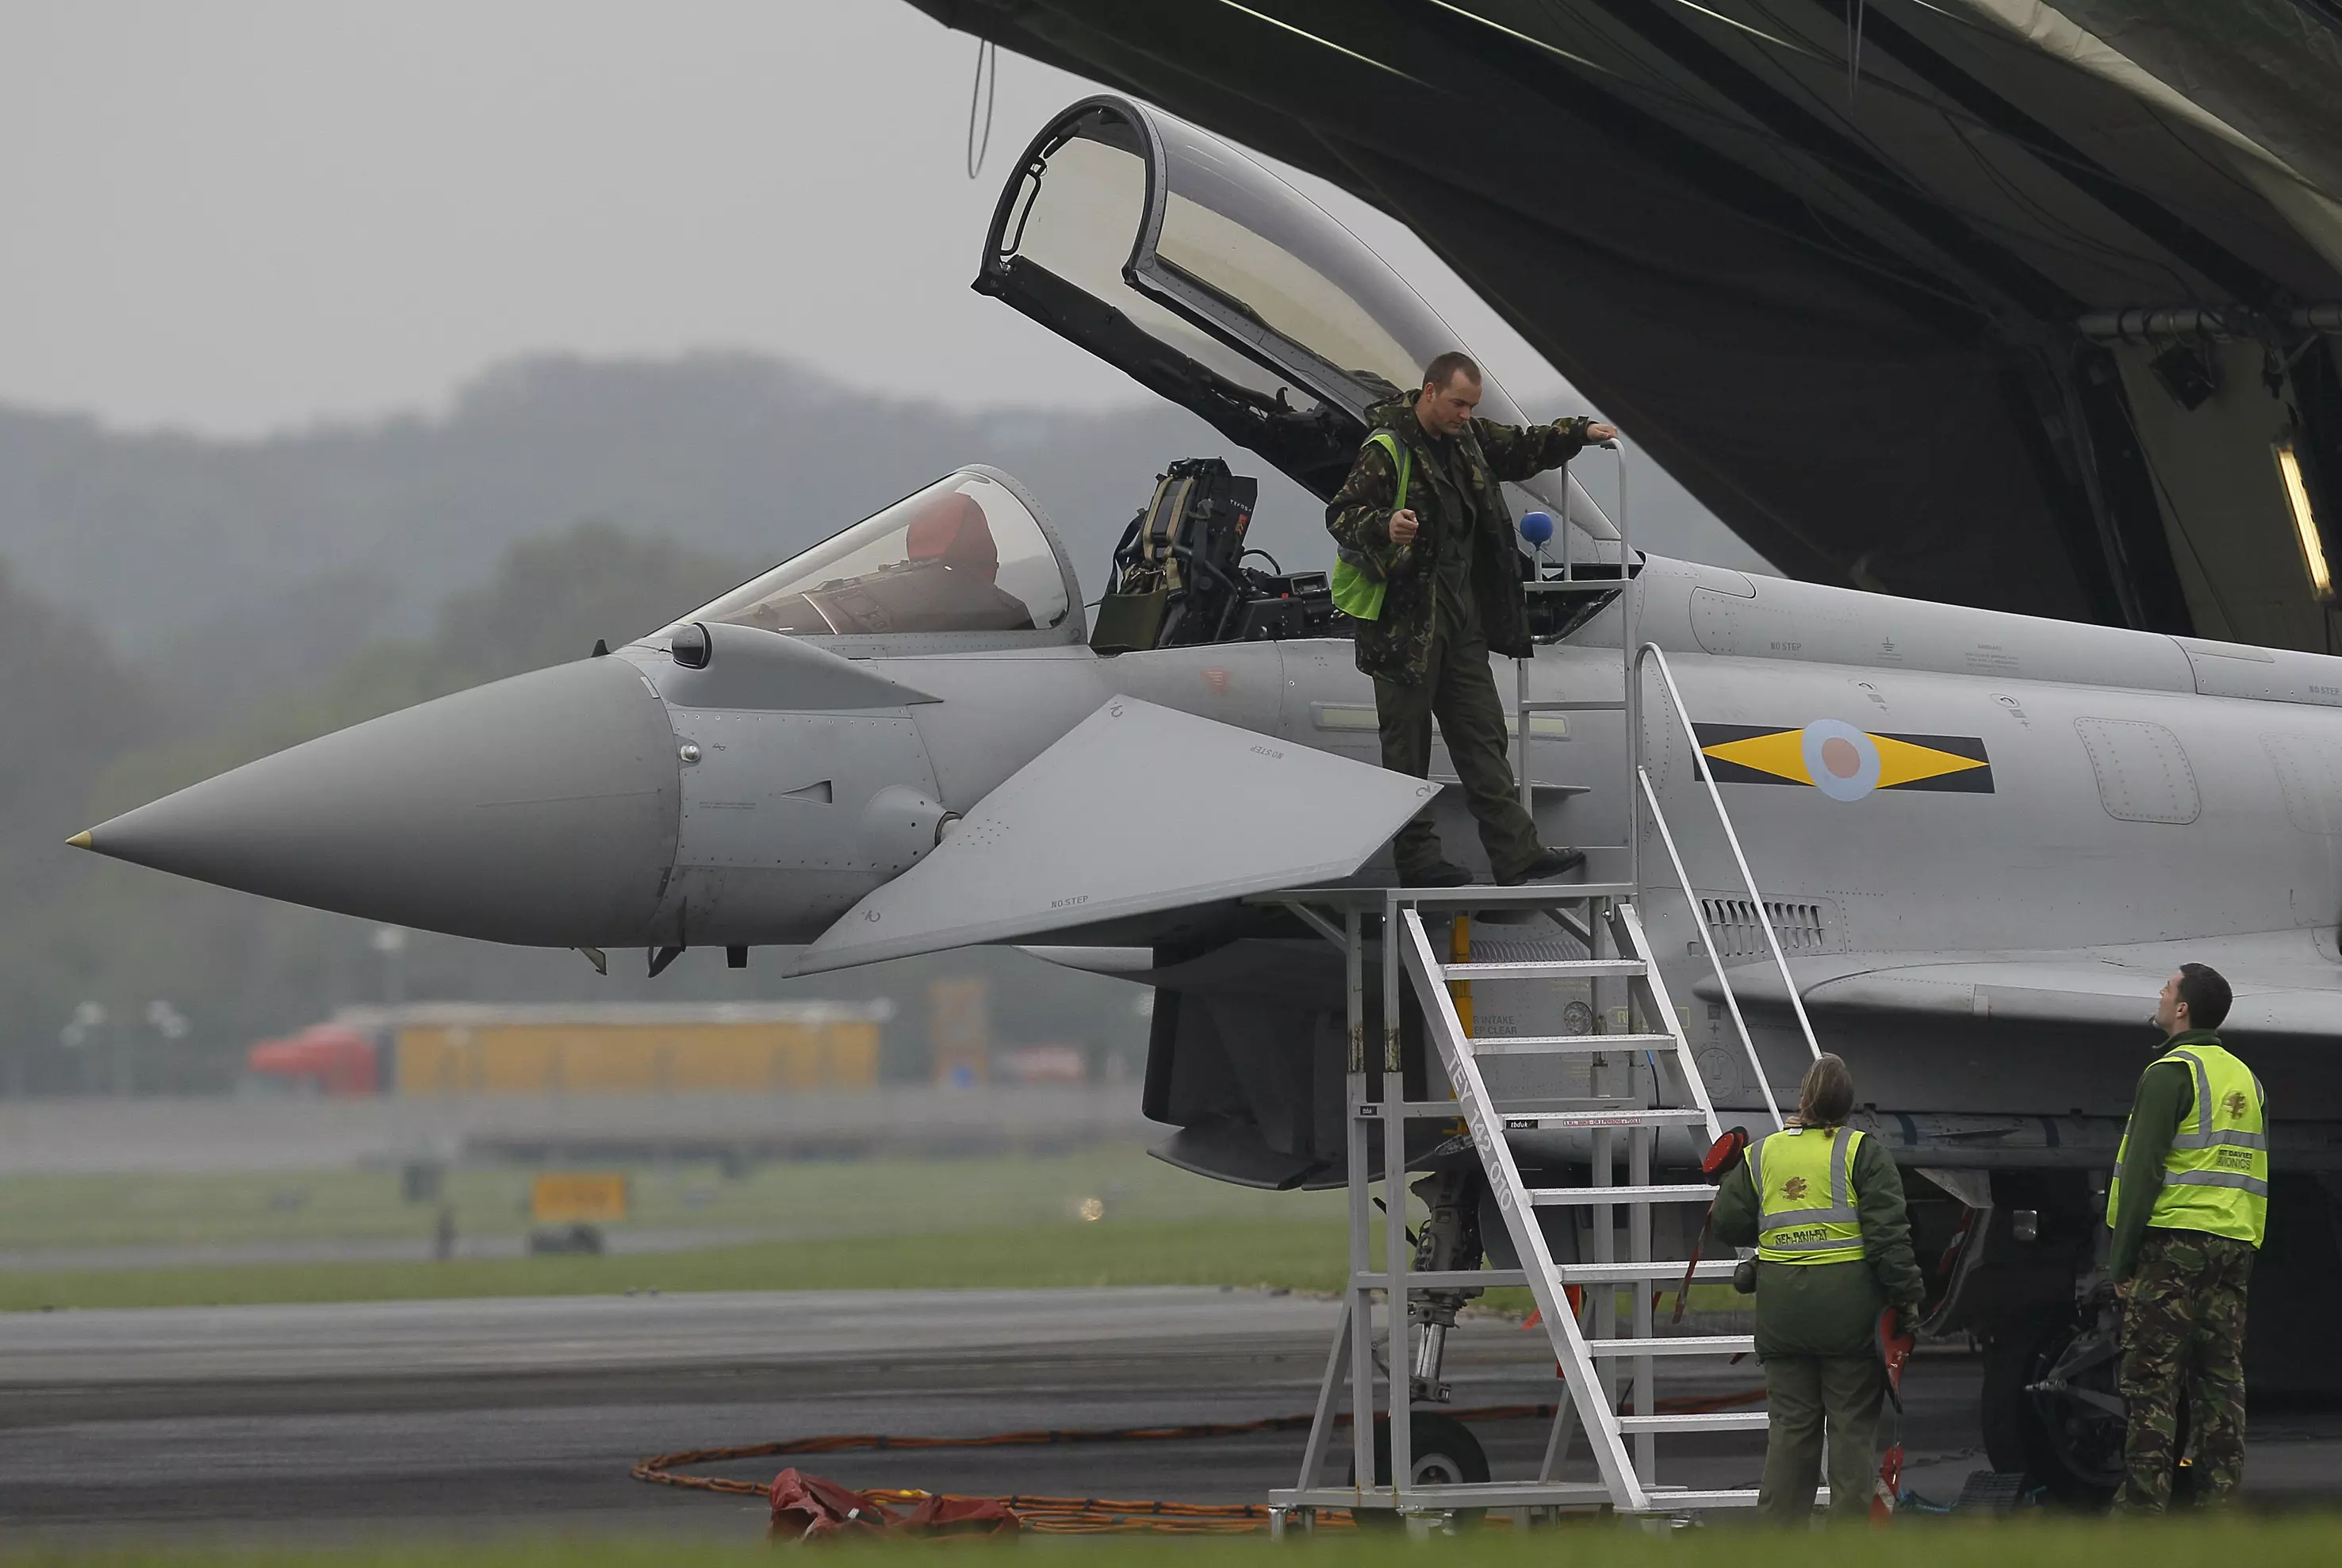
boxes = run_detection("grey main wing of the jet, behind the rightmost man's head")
[1693,930,2342,1036]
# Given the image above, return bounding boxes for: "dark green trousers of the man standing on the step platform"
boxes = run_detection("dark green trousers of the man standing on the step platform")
[1374,619,1543,879]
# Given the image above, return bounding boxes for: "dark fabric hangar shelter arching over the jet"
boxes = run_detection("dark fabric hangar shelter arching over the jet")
[914,0,2342,652]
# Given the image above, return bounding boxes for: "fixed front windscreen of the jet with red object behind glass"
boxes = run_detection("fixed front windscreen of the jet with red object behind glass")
[679,466,1082,652]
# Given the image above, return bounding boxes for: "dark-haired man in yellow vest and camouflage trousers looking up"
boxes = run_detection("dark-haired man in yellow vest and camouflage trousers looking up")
[2106,964,2269,1514]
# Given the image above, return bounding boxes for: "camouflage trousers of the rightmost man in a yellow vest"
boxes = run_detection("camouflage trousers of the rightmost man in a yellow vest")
[2118,1226,2253,1514]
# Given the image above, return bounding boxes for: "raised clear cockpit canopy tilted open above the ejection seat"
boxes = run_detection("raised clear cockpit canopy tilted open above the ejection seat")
[976,98,1616,537]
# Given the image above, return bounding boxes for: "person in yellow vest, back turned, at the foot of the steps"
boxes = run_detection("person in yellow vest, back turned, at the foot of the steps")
[1717,1055,1927,1524]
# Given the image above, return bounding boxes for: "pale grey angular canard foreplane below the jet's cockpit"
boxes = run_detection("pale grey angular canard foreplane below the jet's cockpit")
[794,696,1438,975]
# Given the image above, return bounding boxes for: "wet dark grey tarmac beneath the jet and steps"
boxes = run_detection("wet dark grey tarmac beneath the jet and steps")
[0,1289,2342,1540]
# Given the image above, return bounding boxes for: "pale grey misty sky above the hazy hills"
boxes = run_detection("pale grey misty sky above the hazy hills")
[0,0,1571,434]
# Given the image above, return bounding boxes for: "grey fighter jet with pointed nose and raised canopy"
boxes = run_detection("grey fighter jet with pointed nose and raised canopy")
[75,98,2342,1490]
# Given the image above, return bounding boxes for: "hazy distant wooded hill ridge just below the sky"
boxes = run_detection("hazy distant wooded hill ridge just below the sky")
[0,354,1750,668]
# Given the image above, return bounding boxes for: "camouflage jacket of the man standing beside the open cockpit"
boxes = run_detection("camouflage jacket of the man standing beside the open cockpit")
[1325,393,1588,684]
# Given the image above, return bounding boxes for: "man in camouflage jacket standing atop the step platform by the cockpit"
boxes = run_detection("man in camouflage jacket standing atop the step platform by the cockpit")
[1325,354,1619,888]
